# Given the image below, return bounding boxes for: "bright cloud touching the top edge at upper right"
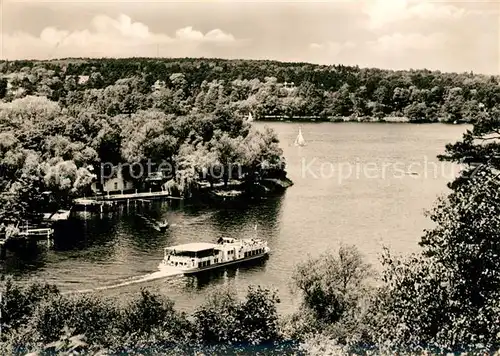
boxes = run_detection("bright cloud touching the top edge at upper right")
[363,0,467,29]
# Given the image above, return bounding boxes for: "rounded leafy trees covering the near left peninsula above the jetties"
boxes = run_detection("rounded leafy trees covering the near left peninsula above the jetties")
[0,67,285,222]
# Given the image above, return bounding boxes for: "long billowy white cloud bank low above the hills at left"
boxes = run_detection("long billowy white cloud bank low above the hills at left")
[2,14,239,59]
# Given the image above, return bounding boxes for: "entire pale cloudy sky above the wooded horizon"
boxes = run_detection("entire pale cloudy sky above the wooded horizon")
[0,0,500,74]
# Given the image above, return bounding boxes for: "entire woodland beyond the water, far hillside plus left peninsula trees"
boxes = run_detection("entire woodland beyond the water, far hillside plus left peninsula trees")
[0,58,500,220]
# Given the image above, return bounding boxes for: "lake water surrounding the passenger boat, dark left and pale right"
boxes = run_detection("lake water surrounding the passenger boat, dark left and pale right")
[2,122,467,313]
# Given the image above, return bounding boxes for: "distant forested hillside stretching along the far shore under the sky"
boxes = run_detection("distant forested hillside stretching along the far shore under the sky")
[0,58,500,122]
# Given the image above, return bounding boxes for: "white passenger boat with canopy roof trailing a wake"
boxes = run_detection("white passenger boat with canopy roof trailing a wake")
[159,238,270,274]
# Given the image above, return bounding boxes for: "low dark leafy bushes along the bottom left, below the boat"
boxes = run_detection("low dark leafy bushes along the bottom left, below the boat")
[1,281,292,355]
